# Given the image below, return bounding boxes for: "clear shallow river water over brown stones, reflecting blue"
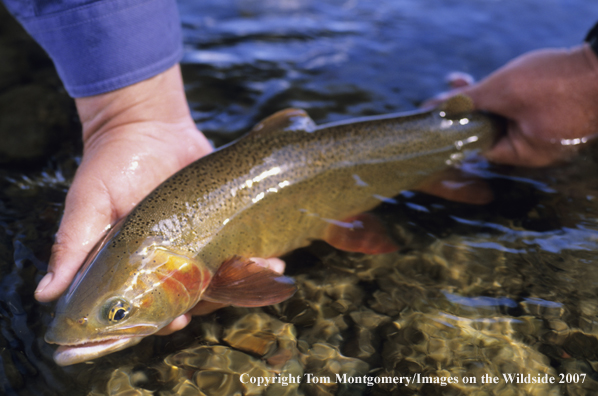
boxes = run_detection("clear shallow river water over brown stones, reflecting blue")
[0,0,598,395]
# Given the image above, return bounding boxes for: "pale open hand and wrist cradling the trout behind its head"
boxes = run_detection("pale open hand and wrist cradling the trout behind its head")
[35,66,212,330]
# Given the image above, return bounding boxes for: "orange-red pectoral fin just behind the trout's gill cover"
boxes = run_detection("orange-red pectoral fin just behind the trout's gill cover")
[202,256,297,307]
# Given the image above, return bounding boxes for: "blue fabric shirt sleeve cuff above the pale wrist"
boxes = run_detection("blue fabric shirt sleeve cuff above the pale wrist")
[2,0,183,97]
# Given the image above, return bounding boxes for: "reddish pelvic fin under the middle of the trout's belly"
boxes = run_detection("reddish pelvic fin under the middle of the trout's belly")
[323,213,399,254]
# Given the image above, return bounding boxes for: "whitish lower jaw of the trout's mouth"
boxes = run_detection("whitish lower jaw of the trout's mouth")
[54,336,144,366]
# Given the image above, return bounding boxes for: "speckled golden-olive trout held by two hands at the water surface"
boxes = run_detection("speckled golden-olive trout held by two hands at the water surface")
[46,96,500,365]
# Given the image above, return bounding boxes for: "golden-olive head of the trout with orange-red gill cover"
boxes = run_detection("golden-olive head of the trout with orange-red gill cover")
[45,223,212,365]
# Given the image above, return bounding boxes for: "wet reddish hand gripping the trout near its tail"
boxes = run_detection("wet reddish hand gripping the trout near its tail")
[440,44,598,167]
